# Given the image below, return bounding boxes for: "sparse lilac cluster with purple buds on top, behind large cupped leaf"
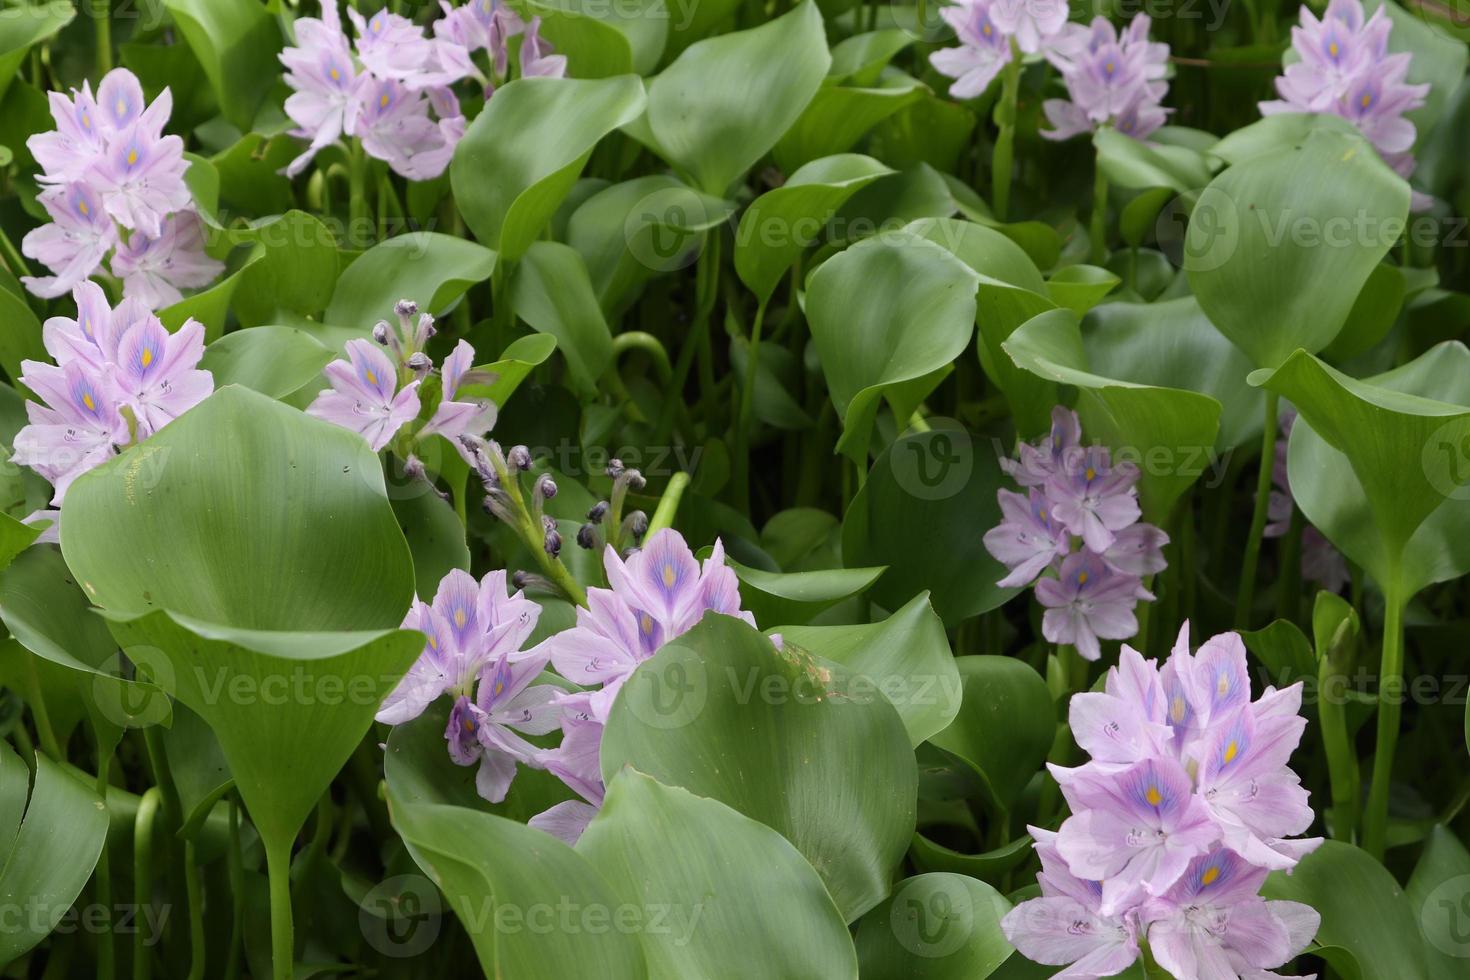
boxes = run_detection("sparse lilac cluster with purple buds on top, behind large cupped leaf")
[306,300,495,469]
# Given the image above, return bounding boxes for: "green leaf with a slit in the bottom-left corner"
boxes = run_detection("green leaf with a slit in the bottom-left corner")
[0,742,107,962]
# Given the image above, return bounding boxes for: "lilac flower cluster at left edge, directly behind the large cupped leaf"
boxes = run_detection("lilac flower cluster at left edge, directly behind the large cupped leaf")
[12,282,215,507]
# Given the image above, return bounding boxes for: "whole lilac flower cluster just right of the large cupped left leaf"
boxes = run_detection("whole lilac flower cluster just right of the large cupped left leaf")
[378,569,562,804]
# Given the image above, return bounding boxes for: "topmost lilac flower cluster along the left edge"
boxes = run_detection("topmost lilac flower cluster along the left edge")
[21,68,225,310]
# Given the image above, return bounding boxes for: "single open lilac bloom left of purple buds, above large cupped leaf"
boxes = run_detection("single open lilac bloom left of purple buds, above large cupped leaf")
[306,339,419,453]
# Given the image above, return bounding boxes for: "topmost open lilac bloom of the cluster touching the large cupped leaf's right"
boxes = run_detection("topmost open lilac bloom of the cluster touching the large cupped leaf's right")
[378,569,541,724]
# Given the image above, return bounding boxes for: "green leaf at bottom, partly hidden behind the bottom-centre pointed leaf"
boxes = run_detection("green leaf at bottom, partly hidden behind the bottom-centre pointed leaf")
[388,792,646,980]
